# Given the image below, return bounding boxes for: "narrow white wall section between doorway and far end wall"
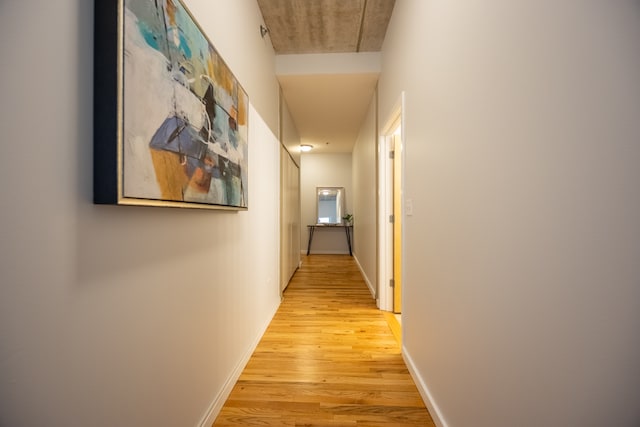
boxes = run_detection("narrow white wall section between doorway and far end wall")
[352,95,378,295]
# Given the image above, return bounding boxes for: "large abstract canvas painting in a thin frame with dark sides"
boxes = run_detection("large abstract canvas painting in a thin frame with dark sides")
[94,0,249,210]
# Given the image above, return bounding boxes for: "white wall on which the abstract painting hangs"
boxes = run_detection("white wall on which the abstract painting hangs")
[0,0,279,427]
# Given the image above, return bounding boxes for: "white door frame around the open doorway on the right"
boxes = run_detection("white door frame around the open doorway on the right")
[377,92,405,311]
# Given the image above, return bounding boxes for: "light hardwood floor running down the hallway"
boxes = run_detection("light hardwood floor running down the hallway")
[213,255,435,427]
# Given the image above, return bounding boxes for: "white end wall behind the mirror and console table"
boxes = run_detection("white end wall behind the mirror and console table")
[300,153,358,254]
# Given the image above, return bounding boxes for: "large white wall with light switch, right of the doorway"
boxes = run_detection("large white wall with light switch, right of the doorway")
[379,0,640,427]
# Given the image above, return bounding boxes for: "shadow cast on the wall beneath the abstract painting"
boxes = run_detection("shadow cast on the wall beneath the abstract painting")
[76,201,239,283]
